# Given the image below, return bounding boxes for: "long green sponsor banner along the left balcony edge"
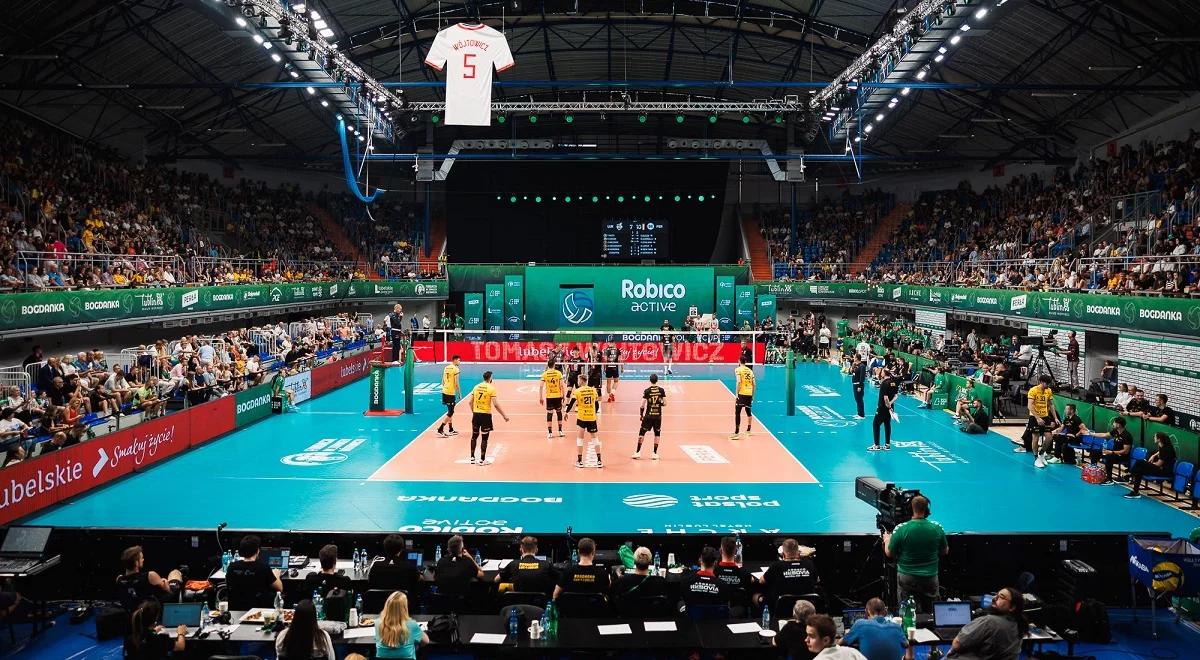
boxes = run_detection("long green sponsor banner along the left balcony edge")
[0,280,450,331]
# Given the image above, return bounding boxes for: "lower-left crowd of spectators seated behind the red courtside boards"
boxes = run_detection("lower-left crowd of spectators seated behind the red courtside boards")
[0,313,376,466]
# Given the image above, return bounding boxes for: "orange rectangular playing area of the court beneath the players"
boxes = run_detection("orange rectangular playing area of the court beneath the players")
[371,379,816,484]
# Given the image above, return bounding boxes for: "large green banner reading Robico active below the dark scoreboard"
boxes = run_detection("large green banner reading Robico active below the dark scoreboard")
[526,265,714,330]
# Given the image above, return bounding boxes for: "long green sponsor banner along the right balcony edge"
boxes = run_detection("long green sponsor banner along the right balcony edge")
[757,282,1200,337]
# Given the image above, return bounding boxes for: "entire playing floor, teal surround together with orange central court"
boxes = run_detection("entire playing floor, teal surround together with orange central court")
[18,364,1200,535]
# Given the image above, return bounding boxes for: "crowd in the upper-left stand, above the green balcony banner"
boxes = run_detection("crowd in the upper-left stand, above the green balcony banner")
[0,115,432,290]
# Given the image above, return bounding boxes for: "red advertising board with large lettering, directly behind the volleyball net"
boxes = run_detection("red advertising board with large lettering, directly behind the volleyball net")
[416,341,766,365]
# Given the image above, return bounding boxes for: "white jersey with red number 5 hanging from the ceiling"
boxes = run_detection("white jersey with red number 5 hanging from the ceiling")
[425,23,514,126]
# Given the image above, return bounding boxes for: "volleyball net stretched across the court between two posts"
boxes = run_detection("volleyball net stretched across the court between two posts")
[412,329,775,366]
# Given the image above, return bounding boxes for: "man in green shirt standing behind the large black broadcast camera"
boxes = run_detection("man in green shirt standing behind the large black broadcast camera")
[883,496,950,612]
